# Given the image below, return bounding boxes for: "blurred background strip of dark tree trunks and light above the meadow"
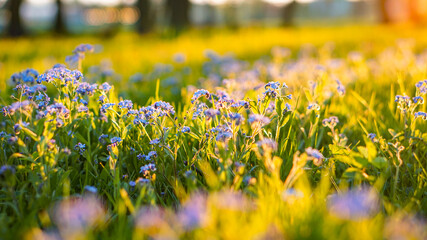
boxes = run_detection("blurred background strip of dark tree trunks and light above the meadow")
[0,0,427,37]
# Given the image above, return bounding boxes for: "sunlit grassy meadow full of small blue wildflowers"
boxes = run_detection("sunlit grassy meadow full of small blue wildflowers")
[0,26,427,239]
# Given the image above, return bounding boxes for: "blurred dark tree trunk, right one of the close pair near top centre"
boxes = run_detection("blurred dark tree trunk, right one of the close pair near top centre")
[166,0,190,31]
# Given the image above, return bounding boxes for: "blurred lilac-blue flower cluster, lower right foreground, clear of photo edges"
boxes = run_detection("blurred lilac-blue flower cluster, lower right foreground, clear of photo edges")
[328,188,379,219]
